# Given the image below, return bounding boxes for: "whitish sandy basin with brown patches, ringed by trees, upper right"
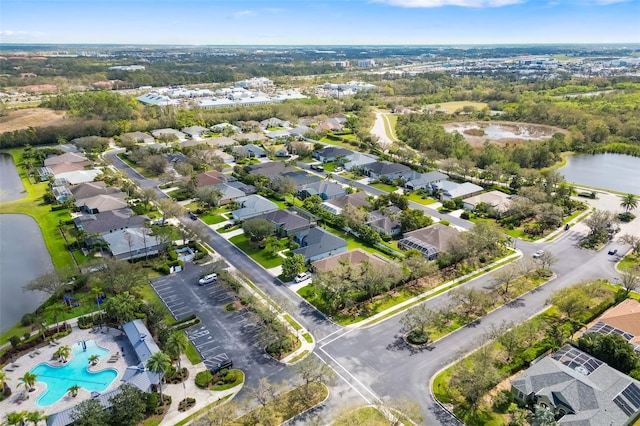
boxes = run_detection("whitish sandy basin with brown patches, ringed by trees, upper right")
[444,121,569,148]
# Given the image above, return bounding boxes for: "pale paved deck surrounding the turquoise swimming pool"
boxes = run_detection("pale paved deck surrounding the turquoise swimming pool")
[0,326,132,415]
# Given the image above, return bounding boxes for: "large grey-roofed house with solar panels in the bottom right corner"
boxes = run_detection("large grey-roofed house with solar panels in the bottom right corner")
[511,345,640,426]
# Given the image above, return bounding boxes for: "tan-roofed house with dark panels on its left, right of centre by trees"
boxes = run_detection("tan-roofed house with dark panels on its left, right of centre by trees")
[398,223,460,260]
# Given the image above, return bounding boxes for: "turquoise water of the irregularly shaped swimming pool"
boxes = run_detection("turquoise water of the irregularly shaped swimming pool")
[31,340,118,407]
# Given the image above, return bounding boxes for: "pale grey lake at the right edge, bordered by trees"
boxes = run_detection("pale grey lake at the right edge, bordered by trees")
[558,154,640,195]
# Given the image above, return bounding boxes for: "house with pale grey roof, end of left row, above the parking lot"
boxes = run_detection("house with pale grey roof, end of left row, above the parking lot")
[102,228,164,260]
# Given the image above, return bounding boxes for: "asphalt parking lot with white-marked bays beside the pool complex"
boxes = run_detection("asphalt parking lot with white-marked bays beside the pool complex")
[151,265,290,385]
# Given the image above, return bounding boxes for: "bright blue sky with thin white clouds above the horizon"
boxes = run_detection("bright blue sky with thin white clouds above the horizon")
[0,0,640,45]
